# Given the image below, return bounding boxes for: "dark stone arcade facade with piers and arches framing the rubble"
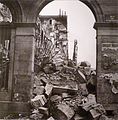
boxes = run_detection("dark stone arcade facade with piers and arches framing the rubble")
[0,0,118,119]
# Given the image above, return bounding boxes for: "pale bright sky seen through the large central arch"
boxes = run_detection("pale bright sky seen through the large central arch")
[40,0,96,68]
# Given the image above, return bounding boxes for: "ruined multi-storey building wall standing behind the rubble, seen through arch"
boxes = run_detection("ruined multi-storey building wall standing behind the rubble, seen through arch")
[35,15,68,70]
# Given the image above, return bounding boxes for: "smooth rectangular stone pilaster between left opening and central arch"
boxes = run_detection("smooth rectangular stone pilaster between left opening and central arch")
[12,23,35,102]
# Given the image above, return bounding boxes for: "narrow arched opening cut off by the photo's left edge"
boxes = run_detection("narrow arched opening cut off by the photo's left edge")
[0,3,12,91]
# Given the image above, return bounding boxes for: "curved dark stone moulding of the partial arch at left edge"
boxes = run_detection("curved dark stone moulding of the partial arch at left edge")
[0,0,22,22]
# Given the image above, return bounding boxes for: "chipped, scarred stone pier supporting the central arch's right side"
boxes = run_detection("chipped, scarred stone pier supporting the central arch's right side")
[95,23,118,110]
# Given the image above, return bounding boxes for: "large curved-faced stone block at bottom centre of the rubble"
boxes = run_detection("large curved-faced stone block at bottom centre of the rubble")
[53,103,74,120]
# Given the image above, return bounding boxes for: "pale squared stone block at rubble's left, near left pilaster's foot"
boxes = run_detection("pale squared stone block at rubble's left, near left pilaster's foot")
[31,95,47,108]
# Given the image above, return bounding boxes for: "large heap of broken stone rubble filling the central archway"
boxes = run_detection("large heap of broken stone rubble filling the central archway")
[30,61,113,120]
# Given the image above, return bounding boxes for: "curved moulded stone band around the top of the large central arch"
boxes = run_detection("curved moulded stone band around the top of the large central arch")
[35,0,104,22]
